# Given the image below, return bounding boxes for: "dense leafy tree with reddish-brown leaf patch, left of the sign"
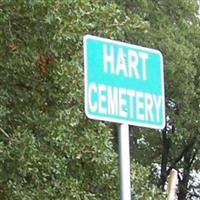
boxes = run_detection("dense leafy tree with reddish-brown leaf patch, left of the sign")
[0,0,159,200]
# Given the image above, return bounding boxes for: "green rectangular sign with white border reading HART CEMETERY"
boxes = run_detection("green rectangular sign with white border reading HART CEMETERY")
[84,35,165,129]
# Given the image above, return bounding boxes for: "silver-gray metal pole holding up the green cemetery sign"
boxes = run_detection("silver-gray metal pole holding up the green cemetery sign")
[118,124,131,200]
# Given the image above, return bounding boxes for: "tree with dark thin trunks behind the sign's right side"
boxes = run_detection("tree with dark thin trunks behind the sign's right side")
[114,0,200,199]
